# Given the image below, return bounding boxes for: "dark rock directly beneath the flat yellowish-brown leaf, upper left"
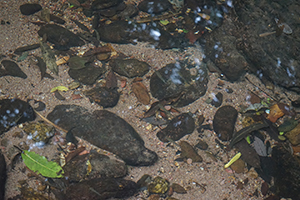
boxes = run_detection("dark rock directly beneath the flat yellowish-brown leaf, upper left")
[68,63,105,85]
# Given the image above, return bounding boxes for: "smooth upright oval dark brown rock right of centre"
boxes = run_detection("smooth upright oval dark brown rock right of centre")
[213,105,238,141]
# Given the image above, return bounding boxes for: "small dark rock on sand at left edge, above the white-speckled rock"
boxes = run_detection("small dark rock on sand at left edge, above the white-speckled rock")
[0,60,27,79]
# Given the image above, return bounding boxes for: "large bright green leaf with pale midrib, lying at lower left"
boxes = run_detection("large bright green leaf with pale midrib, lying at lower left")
[22,150,64,178]
